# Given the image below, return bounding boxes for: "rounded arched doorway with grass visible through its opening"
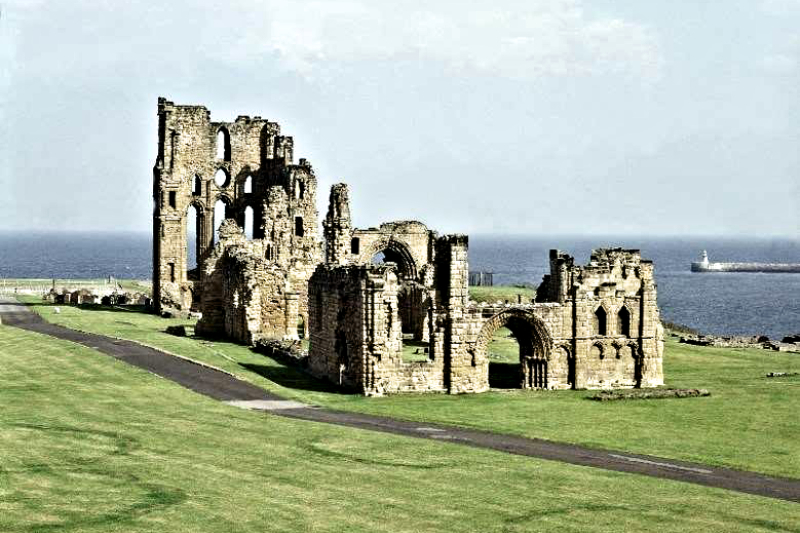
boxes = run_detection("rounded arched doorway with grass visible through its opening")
[476,309,552,389]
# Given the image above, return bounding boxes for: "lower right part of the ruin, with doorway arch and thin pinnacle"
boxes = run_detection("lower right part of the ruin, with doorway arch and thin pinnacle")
[309,184,663,395]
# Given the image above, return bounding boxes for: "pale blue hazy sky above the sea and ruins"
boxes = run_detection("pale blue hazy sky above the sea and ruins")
[0,0,800,237]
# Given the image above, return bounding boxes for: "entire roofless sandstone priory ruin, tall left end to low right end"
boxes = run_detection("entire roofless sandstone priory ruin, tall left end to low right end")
[153,98,663,395]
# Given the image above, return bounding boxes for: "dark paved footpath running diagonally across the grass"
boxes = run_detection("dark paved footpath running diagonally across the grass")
[0,299,800,502]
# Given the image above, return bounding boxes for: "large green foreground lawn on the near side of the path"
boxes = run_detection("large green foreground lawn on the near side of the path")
[0,322,800,533]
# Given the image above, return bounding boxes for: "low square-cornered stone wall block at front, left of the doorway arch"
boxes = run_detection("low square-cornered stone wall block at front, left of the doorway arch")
[308,236,466,395]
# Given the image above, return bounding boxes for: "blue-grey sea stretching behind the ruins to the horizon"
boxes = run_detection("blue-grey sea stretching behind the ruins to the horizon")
[0,232,800,340]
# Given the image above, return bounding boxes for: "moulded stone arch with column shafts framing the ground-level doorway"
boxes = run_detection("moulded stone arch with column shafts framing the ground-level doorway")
[475,308,552,389]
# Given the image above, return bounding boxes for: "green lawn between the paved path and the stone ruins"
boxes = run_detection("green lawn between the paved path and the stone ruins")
[15,296,800,478]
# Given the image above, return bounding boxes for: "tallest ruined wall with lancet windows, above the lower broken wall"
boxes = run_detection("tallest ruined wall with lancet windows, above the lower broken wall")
[153,98,321,311]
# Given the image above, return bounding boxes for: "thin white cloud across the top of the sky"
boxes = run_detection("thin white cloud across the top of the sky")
[212,0,662,79]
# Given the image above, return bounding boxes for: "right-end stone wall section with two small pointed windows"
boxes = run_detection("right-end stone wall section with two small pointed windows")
[537,248,664,388]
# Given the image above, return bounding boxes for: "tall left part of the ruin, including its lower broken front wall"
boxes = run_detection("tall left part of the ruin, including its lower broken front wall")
[153,98,321,342]
